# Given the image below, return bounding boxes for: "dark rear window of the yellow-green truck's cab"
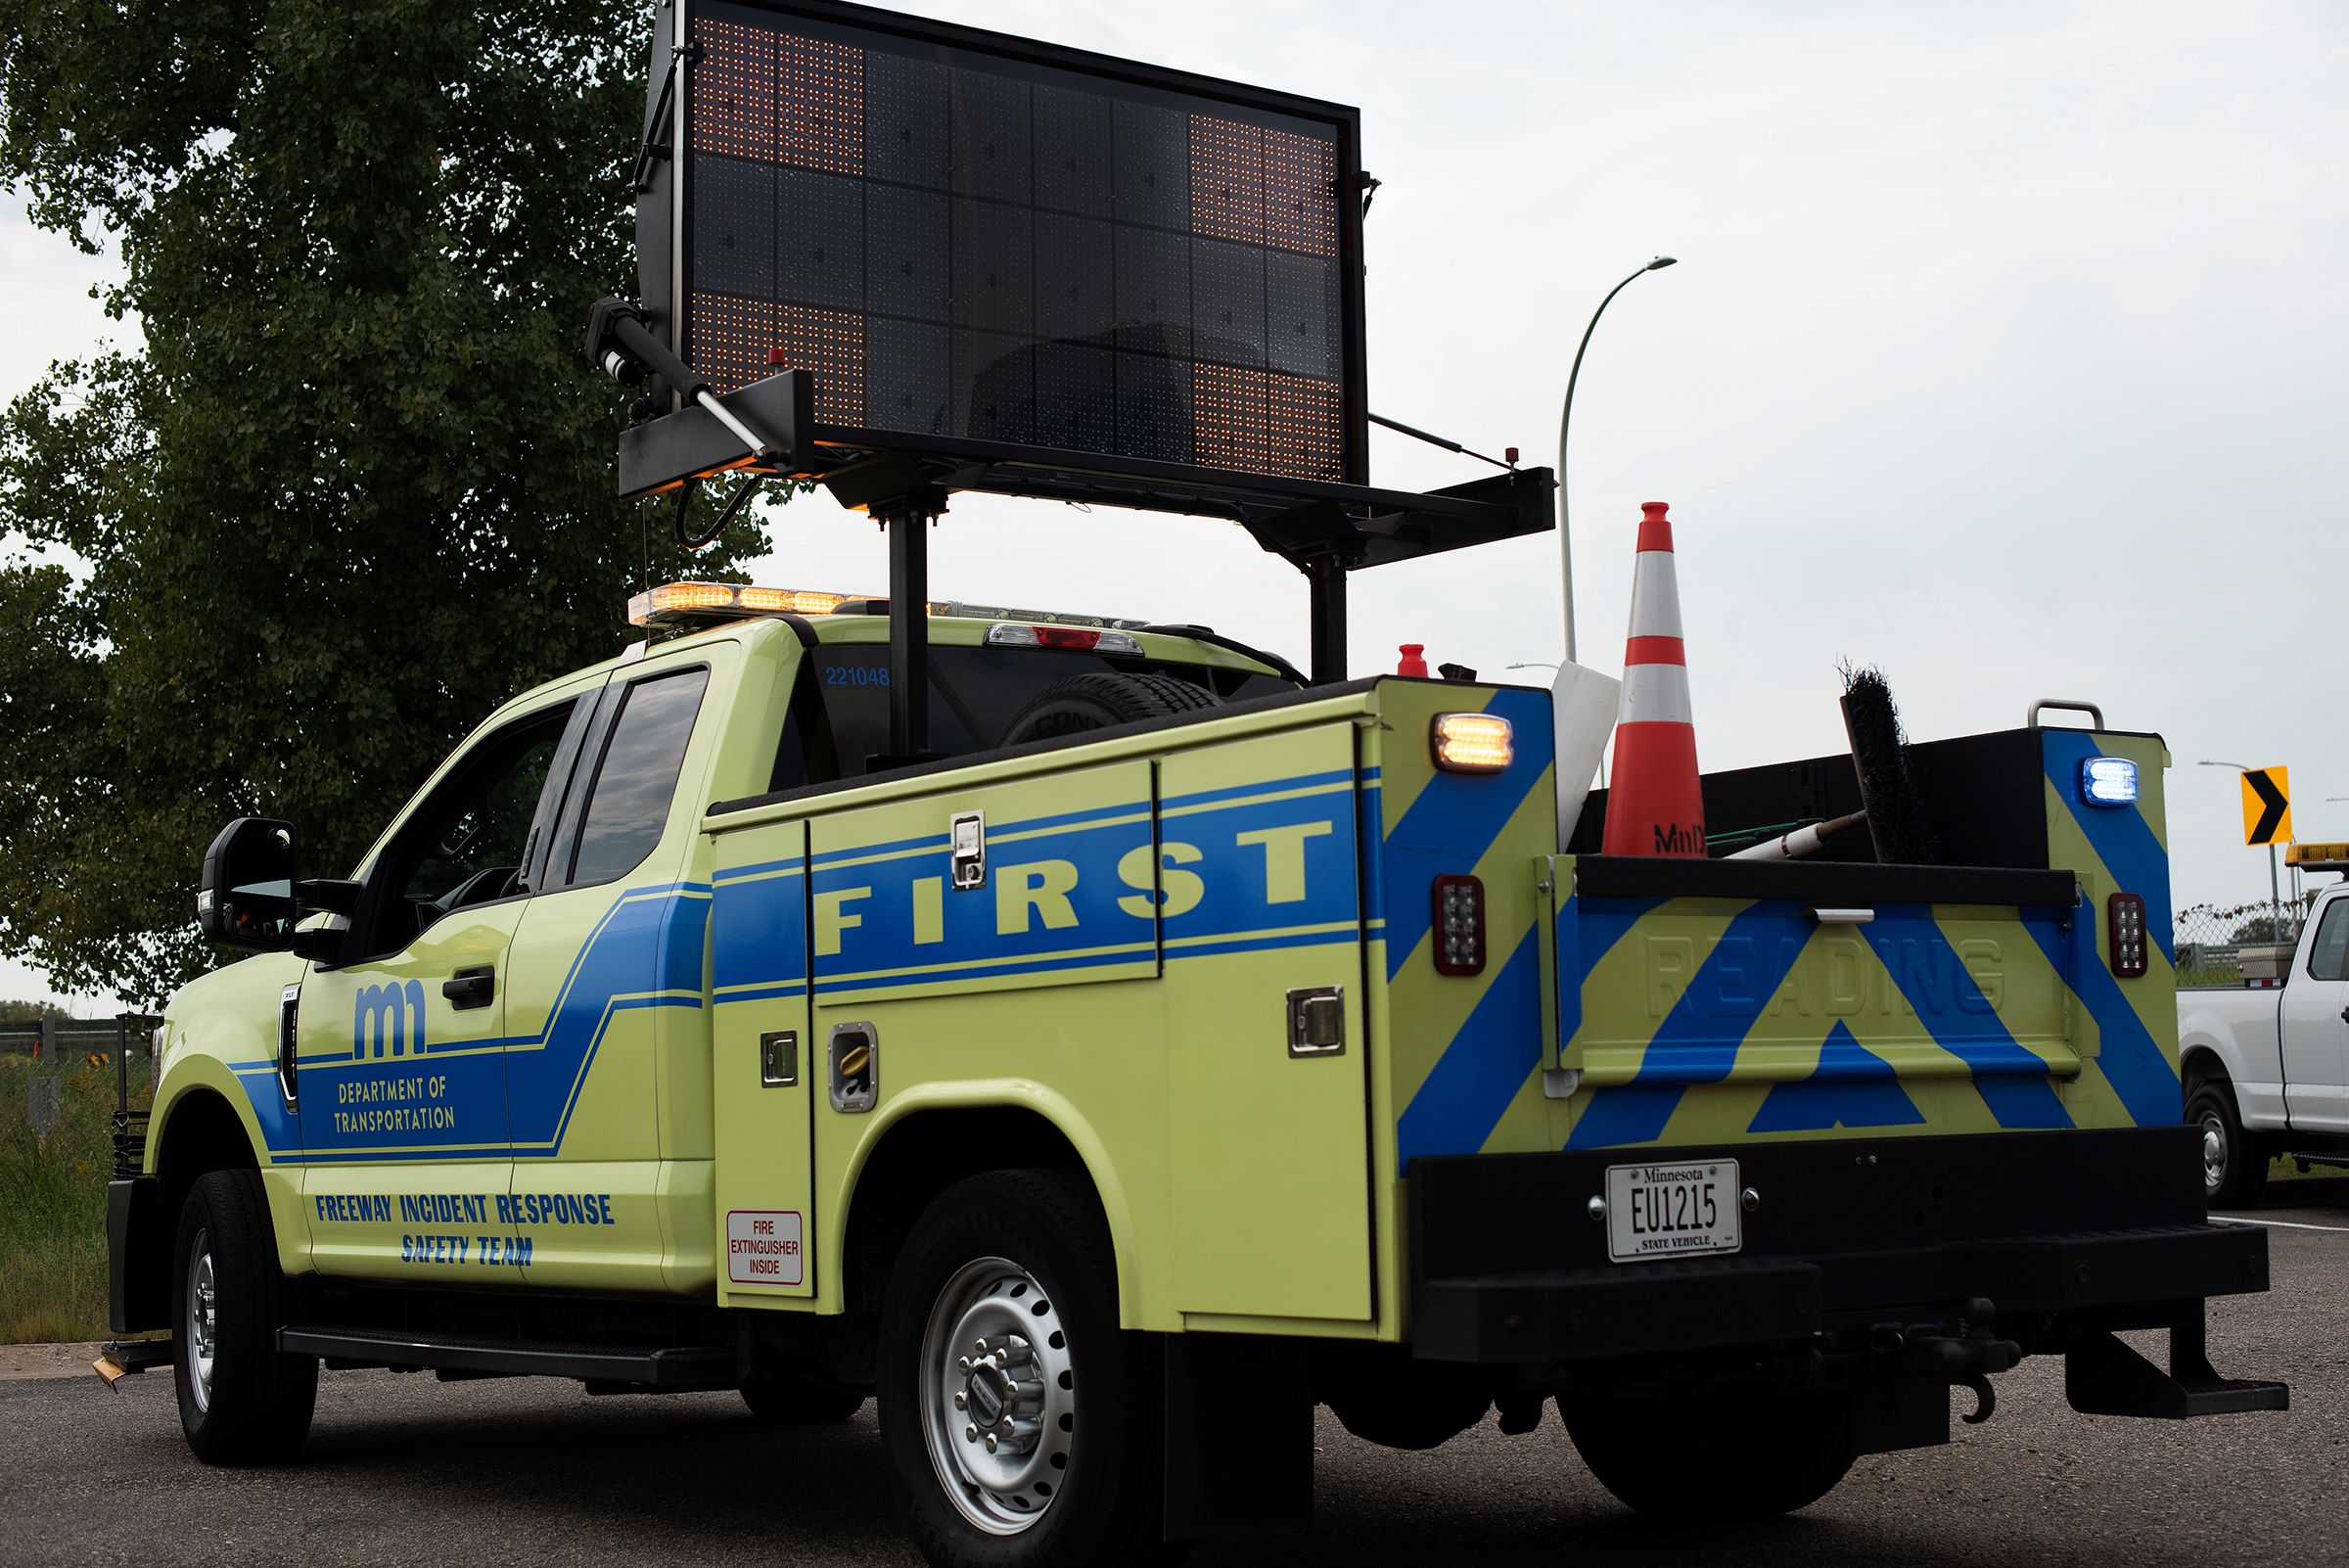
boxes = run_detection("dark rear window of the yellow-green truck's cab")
[770,643,1297,789]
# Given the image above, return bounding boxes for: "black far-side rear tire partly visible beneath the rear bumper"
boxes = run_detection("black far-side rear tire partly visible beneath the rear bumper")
[1557,1387,1854,1521]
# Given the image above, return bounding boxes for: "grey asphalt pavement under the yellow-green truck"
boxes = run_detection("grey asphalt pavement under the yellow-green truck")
[0,1178,2349,1568]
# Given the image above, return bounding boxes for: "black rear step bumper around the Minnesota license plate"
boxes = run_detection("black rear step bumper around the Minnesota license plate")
[1409,1127,2285,1415]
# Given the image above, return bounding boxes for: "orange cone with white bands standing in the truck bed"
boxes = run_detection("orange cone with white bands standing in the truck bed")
[1602,500,1705,856]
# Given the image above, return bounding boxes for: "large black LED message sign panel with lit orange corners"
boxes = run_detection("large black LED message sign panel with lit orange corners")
[648,2,1364,488]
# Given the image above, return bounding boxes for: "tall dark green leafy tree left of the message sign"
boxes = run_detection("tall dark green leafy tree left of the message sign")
[0,0,763,1000]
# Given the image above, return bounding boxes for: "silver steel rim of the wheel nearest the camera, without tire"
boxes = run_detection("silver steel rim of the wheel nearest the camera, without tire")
[921,1258,1076,1535]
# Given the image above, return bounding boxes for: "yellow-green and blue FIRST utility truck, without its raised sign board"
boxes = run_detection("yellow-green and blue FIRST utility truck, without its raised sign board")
[111,584,2283,1563]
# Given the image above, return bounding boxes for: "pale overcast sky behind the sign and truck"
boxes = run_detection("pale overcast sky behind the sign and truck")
[0,0,2349,995]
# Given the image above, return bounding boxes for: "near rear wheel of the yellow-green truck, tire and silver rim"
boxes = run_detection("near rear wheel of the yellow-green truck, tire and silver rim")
[876,1172,1170,1568]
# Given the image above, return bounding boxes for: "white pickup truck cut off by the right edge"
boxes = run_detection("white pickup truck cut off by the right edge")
[2178,863,2349,1207]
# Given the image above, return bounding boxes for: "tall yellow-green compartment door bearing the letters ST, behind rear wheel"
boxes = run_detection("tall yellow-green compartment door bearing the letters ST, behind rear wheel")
[1158,723,1372,1321]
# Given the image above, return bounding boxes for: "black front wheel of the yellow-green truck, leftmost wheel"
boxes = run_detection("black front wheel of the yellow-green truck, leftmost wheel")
[171,1172,317,1464]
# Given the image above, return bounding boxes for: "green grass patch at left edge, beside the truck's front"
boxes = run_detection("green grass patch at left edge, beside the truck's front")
[0,1056,148,1345]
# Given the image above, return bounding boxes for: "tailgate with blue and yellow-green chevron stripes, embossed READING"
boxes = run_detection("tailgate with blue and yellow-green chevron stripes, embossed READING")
[1552,856,2086,1148]
